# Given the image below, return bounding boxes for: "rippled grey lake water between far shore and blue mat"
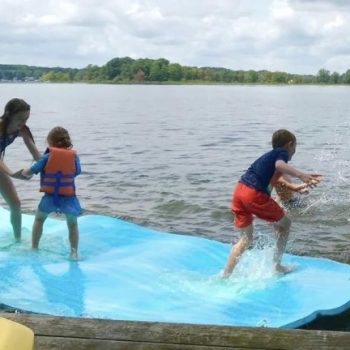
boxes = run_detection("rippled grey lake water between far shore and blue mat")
[0,84,350,263]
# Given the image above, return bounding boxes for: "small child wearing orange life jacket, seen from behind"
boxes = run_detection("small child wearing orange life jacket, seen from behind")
[22,127,81,259]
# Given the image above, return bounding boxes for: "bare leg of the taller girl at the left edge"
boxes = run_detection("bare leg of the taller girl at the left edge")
[0,173,22,241]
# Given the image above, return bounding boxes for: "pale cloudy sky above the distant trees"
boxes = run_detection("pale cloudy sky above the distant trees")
[0,0,350,74]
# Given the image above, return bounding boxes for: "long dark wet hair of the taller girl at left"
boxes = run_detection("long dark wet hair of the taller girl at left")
[0,98,34,157]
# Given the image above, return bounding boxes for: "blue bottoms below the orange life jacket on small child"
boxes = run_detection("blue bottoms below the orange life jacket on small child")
[38,193,82,216]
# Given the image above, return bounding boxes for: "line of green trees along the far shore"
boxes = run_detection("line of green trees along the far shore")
[0,57,350,84]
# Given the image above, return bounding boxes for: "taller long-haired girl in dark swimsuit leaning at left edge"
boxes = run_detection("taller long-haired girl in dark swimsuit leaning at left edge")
[0,98,40,241]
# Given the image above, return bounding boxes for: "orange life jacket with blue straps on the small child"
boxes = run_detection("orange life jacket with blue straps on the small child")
[40,147,76,196]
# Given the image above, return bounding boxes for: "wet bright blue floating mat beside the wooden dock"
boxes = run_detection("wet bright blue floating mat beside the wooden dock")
[0,208,350,328]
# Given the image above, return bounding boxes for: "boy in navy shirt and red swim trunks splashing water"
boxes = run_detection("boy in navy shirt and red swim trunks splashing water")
[224,129,320,277]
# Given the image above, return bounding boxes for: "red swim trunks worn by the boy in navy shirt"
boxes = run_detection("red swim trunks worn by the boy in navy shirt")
[231,182,284,228]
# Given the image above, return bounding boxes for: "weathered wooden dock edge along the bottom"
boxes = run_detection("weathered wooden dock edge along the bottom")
[0,313,350,350]
